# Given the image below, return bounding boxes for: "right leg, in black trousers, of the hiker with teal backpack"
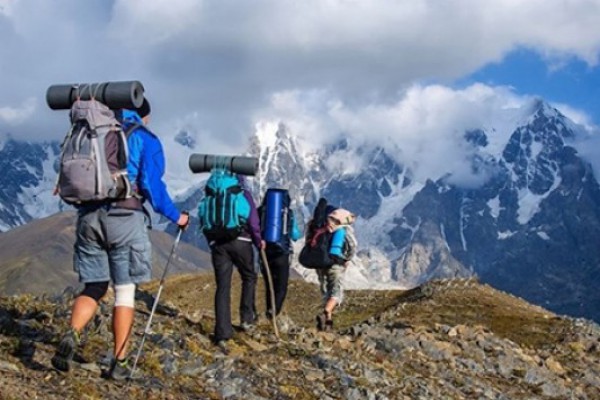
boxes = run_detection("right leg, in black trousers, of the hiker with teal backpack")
[231,240,257,324]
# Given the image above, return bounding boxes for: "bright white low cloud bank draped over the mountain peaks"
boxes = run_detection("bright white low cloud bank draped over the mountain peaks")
[255,84,535,186]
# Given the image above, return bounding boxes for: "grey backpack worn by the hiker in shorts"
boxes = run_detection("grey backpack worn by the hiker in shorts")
[57,100,132,205]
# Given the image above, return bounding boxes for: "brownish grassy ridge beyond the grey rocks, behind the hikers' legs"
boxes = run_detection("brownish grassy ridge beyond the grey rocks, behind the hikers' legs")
[139,272,570,348]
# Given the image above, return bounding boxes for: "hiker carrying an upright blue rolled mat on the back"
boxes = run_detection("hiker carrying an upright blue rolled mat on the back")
[258,188,302,319]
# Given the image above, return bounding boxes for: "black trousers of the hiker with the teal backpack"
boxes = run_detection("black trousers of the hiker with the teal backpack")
[211,239,257,342]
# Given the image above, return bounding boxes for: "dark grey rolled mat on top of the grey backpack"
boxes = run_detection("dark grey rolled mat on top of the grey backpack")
[46,81,144,110]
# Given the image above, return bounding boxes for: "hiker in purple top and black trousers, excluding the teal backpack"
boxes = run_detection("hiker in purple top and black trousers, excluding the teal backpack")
[209,175,265,351]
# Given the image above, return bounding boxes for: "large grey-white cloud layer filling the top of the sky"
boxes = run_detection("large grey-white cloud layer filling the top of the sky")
[0,0,600,145]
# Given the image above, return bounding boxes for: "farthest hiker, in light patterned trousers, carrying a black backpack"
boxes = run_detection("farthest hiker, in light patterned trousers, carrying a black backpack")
[298,198,357,331]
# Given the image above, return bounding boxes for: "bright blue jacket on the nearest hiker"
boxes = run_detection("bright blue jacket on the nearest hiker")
[122,110,181,223]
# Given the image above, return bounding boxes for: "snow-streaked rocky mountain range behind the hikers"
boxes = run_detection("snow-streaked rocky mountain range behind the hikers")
[0,100,600,320]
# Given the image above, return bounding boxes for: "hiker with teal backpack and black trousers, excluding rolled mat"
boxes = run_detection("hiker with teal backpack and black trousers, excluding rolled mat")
[198,172,265,351]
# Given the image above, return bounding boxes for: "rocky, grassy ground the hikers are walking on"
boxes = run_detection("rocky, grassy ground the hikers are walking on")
[0,275,600,400]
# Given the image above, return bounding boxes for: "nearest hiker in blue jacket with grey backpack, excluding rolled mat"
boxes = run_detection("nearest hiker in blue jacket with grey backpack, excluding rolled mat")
[51,99,189,380]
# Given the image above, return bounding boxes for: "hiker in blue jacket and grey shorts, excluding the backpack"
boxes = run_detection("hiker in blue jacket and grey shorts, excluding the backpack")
[52,99,189,380]
